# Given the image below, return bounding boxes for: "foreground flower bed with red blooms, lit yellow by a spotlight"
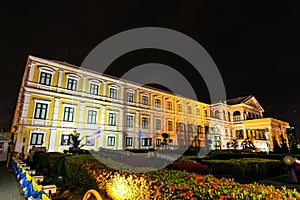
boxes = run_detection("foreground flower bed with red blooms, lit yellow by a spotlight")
[66,155,300,200]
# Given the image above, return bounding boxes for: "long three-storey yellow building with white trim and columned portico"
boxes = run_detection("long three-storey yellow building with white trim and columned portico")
[11,56,289,153]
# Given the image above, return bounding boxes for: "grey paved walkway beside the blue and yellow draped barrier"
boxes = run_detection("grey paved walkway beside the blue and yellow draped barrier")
[0,163,24,200]
